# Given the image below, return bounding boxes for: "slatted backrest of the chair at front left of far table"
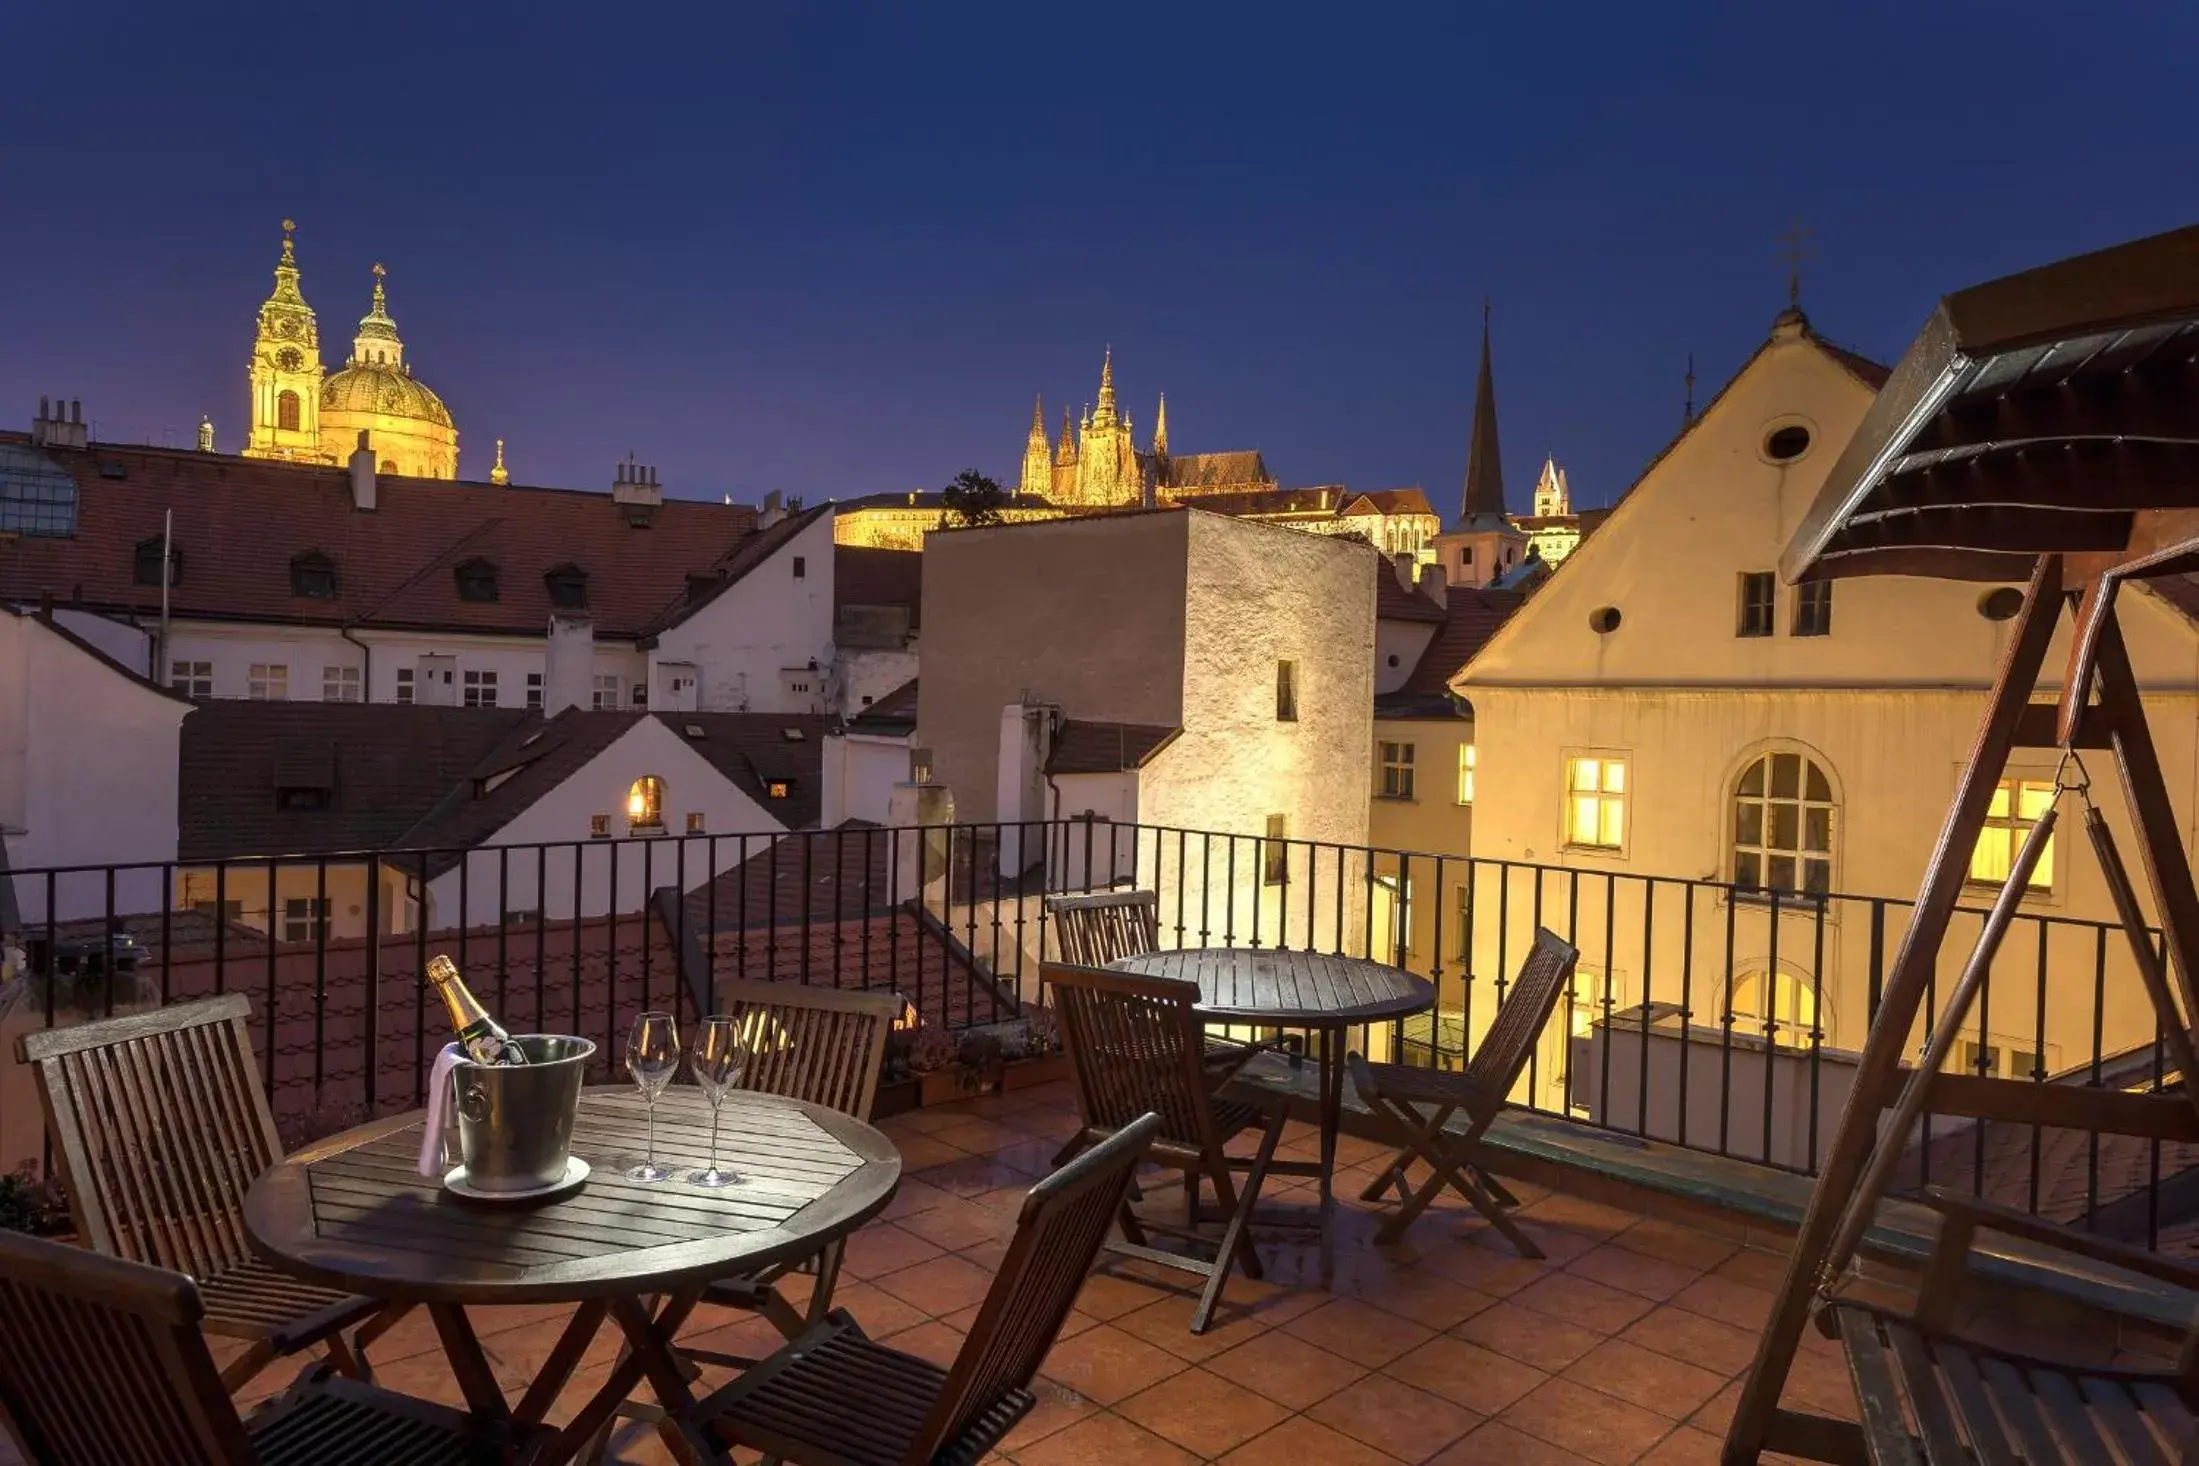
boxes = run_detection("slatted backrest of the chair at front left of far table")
[1040,963,1218,1154]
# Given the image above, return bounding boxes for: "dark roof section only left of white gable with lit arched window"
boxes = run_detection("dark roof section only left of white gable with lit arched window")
[176,701,539,862]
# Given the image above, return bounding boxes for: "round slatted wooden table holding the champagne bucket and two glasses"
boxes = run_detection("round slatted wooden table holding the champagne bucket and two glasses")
[244,1086,902,1462]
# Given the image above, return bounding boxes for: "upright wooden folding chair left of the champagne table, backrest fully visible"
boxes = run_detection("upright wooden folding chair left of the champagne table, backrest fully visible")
[15,993,405,1389]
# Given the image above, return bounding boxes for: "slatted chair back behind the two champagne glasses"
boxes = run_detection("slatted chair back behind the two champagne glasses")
[717,982,902,1121]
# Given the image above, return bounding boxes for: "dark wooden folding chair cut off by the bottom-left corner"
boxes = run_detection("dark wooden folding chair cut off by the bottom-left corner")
[0,1231,528,1466]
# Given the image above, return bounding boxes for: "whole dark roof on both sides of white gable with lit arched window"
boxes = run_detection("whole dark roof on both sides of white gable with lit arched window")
[176,701,825,873]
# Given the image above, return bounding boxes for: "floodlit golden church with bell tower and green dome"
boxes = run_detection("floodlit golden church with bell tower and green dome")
[244,220,461,479]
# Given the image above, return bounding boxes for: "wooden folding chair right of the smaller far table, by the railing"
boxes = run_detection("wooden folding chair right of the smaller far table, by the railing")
[1346,928,1581,1257]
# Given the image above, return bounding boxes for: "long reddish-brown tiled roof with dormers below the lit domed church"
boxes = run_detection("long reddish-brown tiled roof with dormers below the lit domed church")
[0,433,756,637]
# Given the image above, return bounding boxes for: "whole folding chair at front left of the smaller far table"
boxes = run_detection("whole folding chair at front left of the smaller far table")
[1042,965,1289,1334]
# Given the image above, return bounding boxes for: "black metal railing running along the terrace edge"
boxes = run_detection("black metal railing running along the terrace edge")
[0,820,2199,1242]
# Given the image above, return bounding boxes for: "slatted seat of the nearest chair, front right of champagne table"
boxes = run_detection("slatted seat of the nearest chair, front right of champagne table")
[710,1308,1038,1466]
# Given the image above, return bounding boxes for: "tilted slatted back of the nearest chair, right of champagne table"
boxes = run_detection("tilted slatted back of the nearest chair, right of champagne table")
[904,1114,1161,1466]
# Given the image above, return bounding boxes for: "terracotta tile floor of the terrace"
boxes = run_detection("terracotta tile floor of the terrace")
[0,1086,2128,1466]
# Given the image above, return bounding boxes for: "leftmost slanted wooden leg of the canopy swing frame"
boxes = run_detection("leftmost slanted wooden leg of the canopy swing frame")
[1720,554,2063,1466]
